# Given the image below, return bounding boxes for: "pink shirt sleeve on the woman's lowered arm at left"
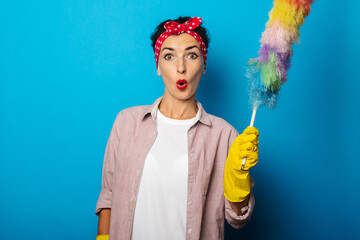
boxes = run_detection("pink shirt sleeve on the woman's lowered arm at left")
[95,112,121,215]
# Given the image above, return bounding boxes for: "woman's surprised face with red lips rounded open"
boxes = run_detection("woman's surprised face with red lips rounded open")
[157,33,205,100]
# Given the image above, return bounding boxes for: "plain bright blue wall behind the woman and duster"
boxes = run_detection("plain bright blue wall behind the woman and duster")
[0,0,360,239]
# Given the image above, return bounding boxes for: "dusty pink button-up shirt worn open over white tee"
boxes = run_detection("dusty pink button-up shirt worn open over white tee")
[95,97,255,240]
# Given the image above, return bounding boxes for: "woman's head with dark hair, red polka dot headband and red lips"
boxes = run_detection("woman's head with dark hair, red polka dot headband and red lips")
[151,17,209,100]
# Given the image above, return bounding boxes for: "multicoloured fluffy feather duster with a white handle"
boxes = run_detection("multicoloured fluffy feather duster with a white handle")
[242,0,314,169]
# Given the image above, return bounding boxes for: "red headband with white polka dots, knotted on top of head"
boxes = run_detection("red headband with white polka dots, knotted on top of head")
[154,17,207,68]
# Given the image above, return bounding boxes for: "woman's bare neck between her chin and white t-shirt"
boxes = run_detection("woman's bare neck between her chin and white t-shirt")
[159,94,198,120]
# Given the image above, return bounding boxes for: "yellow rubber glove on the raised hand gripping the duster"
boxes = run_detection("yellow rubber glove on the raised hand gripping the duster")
[224,127,259,202]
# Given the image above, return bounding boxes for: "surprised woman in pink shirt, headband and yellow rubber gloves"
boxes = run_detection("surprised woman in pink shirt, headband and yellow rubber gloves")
[95,17,259,240]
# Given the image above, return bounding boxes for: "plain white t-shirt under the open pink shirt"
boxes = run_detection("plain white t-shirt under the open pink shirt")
[132,110,199,240]
